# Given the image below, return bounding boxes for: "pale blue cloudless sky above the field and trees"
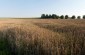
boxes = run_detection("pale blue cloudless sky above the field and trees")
[0,0,85,17]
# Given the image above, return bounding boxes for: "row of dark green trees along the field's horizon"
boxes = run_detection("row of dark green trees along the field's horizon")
[41,14,85,19]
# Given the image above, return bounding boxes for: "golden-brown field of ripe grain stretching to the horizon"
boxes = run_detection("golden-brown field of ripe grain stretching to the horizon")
[0,19,85,55]
